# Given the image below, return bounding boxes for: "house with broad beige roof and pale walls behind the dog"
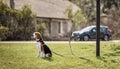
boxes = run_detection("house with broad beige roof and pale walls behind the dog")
[4,0,79,40]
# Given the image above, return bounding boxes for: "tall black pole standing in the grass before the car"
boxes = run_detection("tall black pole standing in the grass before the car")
[96,0,100,57]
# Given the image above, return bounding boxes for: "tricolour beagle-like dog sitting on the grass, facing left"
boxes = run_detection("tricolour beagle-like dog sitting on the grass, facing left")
[33,32,52,58]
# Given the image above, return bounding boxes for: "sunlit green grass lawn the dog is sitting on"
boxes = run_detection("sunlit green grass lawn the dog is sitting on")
[0,43,120,69]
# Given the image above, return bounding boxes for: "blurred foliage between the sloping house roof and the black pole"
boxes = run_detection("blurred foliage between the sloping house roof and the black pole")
[69,0,96,22]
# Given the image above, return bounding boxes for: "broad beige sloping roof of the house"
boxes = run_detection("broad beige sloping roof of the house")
[11,0,79,19]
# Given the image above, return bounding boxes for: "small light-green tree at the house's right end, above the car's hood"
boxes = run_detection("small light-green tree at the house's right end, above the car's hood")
[65,6,87,32]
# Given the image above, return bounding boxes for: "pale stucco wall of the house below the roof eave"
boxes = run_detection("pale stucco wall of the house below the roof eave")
[36,18,72,37]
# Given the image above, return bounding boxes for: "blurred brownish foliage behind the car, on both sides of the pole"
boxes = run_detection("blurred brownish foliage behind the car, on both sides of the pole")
[69,0,120,39]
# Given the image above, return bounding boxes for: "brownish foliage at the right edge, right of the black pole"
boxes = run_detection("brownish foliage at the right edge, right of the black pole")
[102,0,120,39]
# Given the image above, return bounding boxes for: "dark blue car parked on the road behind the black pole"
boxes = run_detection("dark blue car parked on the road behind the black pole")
[72,26,112,41]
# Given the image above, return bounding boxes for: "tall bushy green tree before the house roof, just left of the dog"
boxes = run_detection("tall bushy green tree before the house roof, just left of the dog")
[15,5,35,40]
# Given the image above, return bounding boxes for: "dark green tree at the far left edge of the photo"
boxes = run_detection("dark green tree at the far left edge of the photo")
[0,1,11,40]
